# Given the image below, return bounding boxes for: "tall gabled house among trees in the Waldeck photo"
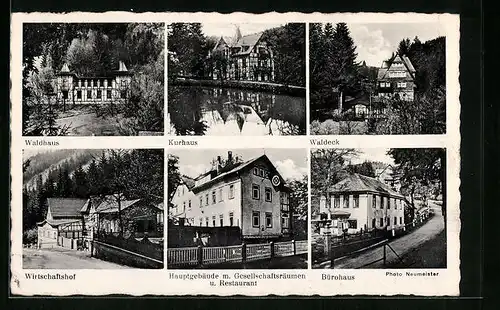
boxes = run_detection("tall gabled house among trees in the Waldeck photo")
[377,54,416,101]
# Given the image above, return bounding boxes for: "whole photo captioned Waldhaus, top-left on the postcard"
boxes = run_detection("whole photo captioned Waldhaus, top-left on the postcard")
[22,23,165,136]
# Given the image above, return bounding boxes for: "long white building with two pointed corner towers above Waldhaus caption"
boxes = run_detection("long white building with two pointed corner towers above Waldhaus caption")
[56,61,132,104]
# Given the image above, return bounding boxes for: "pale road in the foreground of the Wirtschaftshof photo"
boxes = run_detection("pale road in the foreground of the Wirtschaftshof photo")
[23,247,130,269]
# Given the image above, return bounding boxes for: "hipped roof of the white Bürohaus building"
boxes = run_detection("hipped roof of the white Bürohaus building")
[329,173,403,198]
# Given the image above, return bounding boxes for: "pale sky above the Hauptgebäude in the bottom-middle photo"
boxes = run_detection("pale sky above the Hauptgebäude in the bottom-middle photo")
[170,149,308,180]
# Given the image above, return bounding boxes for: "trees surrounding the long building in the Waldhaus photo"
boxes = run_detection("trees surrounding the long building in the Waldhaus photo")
[23,23,164,135]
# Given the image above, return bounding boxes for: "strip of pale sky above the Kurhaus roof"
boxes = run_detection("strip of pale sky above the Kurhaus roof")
[201,23,283,37]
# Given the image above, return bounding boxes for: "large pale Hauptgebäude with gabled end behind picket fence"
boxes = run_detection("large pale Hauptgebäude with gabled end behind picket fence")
[169,152,291,240]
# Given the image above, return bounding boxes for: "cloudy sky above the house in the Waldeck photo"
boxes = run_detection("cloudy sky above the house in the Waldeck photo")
[347,22,445,67]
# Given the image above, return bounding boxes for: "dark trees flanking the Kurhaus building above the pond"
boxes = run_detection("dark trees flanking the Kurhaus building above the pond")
[168,23,306,87]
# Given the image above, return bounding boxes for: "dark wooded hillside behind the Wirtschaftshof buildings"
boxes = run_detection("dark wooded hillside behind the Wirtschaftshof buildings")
[23,149,164,242]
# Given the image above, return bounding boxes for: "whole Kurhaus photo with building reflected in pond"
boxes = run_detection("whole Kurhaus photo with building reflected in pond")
[167,22,307,136]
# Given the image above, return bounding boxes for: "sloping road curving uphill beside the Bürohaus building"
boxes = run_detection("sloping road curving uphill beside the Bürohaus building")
[322,202,445,269]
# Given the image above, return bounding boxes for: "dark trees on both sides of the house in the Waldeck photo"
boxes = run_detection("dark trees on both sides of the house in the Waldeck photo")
[309,23,446,134]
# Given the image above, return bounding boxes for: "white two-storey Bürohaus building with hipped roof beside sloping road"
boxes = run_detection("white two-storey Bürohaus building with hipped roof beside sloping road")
[313,173,406,235]
